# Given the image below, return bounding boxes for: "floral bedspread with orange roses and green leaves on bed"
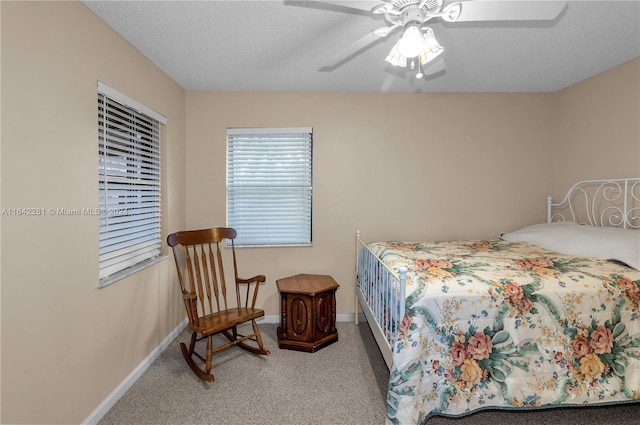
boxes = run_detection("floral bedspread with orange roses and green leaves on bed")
[369,240,640,424]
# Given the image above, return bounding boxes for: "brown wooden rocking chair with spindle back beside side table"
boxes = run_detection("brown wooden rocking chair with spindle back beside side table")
[167,227,270,382]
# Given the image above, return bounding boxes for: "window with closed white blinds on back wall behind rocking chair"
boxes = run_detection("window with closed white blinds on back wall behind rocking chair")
[227,128,313,246]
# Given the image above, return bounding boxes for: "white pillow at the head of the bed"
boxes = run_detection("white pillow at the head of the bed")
[500,221,640,270]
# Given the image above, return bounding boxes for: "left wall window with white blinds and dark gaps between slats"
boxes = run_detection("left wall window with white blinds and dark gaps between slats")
[98,82,166,286]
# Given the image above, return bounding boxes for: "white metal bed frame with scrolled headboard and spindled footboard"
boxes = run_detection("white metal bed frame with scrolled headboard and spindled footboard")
[355,178,640,369]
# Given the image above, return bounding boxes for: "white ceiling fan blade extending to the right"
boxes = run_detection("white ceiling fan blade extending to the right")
[450,0,567,22]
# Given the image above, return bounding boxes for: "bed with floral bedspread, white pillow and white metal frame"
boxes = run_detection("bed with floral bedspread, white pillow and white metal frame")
[355,178,640,424]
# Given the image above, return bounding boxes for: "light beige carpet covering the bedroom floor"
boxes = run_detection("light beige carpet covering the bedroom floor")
[99,322,640,425]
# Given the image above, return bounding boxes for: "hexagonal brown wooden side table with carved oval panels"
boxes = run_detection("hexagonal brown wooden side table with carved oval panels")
[276,274,340,353]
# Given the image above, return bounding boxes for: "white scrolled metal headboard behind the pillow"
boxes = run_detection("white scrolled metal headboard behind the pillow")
[547,178,640,229]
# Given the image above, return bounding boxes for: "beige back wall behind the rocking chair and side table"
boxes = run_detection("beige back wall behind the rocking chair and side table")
[186,92,553,315]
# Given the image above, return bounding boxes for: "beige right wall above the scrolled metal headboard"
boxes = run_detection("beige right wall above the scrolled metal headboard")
[553,59,640,200]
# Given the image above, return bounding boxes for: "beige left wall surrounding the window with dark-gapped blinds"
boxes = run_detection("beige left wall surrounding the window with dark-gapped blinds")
[0,1,185,424]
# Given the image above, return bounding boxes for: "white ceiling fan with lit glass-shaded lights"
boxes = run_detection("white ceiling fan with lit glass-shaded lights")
[312,0,566,78]
